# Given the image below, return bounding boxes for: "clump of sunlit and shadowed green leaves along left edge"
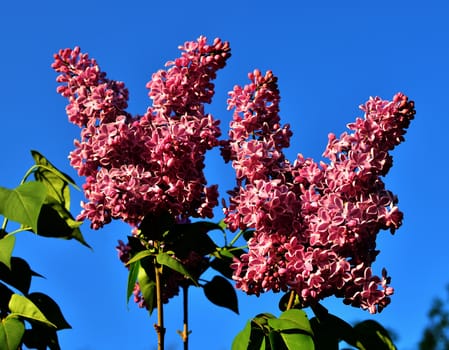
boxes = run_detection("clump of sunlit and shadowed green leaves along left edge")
[0,151,87,350]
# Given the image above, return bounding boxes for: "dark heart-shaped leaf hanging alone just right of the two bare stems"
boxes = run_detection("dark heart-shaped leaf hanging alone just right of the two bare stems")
[203,276,239,315]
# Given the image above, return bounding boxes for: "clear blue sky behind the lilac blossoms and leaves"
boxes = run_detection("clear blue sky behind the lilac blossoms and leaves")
[0,0,449,350]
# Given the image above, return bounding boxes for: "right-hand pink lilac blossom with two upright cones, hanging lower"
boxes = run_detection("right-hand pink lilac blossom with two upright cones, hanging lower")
[222,71,415,313]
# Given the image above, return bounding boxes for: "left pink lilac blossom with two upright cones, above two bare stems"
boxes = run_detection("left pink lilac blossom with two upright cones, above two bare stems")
[52,37,230,229]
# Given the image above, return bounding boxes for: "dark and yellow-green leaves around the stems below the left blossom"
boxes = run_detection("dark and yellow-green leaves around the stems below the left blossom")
[127,214,243,314]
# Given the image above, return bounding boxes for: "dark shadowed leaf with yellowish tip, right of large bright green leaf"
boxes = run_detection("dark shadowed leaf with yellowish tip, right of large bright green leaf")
[35,203,90,248]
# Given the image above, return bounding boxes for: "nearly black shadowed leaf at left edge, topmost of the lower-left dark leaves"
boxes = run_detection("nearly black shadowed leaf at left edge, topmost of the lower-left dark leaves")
[0,257,40,294]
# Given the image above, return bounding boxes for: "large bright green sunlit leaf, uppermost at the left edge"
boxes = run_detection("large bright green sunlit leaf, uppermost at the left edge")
[0,181,47,232]
